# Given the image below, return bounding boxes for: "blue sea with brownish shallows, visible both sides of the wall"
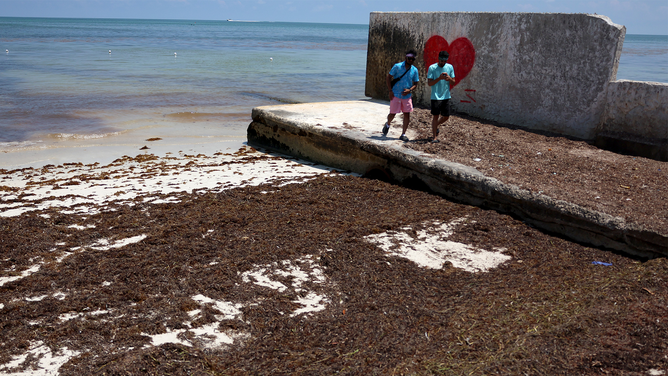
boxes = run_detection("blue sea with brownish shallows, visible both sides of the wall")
[0,17,668,168]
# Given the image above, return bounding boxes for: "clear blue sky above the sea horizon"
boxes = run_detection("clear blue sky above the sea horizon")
[0,0,668,35]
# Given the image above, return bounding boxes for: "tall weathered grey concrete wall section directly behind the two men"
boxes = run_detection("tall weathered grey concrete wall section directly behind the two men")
[366,12,626,140]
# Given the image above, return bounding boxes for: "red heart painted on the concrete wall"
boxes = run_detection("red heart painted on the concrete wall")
[423,35,475,88]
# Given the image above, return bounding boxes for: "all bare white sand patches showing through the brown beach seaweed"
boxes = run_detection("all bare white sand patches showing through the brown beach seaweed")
[0,142,510,375]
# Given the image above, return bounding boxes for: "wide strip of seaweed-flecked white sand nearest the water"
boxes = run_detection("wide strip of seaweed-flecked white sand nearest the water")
[0,147,344,217]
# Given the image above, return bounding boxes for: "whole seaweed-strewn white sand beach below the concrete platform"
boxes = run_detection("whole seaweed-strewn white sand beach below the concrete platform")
[0,128,668,375]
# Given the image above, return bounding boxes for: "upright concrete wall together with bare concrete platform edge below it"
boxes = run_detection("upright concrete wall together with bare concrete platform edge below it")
[247,12,668,257]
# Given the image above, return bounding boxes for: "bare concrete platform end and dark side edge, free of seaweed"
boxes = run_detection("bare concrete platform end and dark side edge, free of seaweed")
[248,101,668,256]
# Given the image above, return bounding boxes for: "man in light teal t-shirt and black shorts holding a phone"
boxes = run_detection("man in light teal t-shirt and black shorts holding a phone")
[427,51,455,142]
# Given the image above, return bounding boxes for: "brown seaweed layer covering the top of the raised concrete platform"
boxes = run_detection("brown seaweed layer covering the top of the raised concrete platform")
[402,109,668,234]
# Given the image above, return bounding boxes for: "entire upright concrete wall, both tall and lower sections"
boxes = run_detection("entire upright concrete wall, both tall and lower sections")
[365,12,668,160]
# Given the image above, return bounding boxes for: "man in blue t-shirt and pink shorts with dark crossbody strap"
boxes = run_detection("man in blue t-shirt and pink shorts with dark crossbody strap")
[383,50,420,142]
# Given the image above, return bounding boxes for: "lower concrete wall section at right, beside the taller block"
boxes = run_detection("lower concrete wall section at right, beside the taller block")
[596,80,668,161]
